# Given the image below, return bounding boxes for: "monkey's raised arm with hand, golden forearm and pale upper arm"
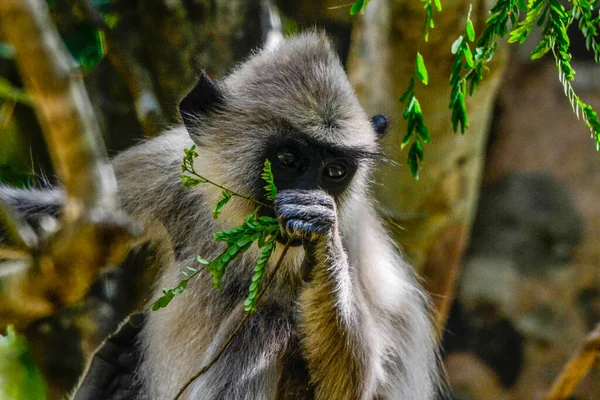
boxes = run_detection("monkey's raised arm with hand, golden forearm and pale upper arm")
[275,190,437,400]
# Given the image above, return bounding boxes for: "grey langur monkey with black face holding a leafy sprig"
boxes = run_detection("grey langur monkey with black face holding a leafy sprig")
[0,31,443,400]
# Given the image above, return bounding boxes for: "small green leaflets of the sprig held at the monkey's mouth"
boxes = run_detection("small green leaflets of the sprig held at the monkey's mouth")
[152,150,279,312]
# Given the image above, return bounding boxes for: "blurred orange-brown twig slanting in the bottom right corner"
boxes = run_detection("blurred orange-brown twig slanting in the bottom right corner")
[545,324,600,400]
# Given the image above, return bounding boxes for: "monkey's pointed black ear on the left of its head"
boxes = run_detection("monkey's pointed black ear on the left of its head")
[179,71,224,127]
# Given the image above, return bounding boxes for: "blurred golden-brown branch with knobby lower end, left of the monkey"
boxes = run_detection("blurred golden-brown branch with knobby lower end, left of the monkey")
[0,0,132,324]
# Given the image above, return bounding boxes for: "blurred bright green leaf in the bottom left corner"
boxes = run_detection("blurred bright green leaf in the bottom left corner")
[0,326,48,400]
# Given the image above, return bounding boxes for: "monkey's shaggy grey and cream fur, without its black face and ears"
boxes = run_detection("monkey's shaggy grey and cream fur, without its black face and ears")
[115,33,438,400]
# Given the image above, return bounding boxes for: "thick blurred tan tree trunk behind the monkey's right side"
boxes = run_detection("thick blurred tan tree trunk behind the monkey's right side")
[348,0,506,332]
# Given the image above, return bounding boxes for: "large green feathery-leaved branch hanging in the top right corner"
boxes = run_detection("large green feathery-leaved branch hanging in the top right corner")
[450,0,600,150]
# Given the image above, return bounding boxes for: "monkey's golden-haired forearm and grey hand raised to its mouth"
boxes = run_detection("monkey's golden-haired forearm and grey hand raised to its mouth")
[275,190,381,399]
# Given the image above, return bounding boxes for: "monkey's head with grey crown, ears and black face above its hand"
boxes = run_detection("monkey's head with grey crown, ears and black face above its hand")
[180,32,388,222]
